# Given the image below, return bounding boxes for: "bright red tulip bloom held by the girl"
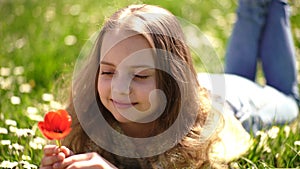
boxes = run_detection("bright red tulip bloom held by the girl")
[38,110,72,146]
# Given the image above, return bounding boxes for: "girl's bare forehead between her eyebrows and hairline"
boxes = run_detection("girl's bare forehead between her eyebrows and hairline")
[100,31,154,67]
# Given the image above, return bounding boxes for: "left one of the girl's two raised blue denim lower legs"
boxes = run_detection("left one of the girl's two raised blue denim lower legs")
[225,0,270,81]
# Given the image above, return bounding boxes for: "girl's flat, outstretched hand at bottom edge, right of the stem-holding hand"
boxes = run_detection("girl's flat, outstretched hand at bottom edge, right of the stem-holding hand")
[53,153,116,169]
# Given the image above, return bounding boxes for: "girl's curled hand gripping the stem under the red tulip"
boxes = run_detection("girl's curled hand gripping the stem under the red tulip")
[40,145,73,169]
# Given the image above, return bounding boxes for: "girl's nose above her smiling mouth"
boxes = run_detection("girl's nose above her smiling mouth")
[111,73,132,95]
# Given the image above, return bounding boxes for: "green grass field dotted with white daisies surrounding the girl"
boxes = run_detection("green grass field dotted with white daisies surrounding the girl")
[0,0,300,168]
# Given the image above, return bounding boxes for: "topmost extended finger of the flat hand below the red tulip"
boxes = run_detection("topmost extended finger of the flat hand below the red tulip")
[53,153,92,168]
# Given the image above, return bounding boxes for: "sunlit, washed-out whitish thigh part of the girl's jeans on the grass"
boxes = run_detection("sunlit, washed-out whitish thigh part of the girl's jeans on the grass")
[198,73,299,134]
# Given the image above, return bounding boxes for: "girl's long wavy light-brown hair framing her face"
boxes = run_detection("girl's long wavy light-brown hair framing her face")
[63,5,223,168]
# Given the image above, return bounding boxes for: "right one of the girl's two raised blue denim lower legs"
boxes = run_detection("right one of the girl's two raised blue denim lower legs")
[259,0,298,99]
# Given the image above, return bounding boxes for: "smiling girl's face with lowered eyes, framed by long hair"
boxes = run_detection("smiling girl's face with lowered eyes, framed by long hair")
[98,32,159,123]
